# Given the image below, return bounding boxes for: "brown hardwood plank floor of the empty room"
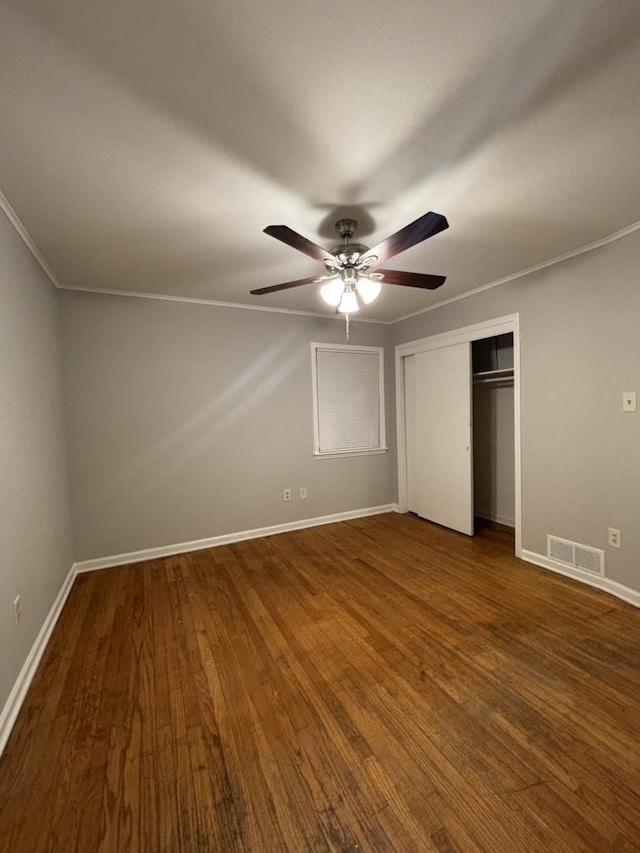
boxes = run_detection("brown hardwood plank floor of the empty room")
[0,514,640,853]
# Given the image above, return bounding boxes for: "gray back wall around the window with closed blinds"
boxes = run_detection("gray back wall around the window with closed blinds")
[60,291,396,560]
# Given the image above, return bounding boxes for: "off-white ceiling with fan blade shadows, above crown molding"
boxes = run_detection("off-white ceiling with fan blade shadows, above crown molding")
[0,0,640,321]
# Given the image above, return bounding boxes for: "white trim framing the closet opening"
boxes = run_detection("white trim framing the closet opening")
[395,314,522,557]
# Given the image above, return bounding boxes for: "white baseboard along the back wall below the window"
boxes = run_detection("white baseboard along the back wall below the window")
[73,504,398,572]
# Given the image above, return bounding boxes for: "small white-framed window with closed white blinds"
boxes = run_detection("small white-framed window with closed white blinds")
[311,343,387,456]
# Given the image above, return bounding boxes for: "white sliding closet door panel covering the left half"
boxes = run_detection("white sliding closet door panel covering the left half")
[405,343,473,536]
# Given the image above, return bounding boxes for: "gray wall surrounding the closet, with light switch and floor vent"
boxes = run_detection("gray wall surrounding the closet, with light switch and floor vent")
[393,225,640,590]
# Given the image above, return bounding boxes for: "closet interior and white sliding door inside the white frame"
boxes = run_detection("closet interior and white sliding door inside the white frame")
[401,332,516,535]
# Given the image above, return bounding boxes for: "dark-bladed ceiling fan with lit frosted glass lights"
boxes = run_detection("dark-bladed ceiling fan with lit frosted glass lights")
[251,212,449,319]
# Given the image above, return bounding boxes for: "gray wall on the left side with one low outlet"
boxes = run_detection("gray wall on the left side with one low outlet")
[0,212,73,709]
